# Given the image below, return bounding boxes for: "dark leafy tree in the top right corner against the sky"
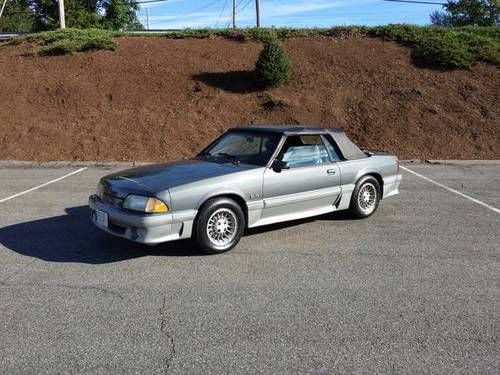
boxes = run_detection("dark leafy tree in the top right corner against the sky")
[431,0,500,26]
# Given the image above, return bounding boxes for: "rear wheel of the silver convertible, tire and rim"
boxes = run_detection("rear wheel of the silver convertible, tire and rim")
[349,176,381,219]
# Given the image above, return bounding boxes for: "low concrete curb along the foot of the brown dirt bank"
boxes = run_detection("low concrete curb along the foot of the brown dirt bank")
[0,160,500,169]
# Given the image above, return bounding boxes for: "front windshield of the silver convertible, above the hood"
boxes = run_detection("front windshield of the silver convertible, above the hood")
[198,131,280,166]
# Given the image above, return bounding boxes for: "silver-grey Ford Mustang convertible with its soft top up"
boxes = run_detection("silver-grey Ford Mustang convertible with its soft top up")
[89,126,401,253]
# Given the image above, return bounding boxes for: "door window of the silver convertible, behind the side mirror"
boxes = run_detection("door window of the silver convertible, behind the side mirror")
[278,135,330,168]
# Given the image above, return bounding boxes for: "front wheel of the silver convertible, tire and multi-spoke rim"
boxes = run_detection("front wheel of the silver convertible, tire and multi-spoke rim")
[193,198,245,254]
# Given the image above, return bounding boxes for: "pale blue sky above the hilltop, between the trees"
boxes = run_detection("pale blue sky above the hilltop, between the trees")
[139,0,445,29]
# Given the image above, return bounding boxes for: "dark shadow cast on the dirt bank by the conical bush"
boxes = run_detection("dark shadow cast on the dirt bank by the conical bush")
[193,70,262,94]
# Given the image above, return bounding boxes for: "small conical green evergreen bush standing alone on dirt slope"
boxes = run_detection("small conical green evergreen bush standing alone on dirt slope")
[256,38,292,87]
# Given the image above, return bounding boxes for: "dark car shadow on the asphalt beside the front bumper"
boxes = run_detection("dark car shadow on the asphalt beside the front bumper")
[0,206,200,264]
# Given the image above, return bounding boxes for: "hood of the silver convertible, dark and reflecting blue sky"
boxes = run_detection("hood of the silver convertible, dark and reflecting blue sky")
[101,159,256,198]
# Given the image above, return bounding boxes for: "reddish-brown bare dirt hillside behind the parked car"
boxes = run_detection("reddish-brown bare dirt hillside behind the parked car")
[0,37,500,161]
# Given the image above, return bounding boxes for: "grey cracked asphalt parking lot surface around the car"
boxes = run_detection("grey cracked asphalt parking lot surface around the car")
[0,164,500,374]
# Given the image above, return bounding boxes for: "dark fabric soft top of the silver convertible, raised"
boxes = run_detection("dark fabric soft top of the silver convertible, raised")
[231,125,368,160]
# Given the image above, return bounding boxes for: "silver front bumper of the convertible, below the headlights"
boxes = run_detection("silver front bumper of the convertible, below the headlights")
[89,195,196,244]
